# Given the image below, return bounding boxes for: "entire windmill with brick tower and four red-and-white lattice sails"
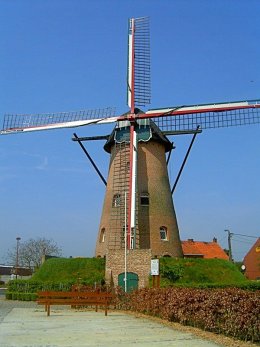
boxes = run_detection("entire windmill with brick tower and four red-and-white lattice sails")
[1,17,260,290]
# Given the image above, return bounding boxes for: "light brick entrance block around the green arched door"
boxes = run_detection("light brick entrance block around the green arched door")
[106,249,152,289]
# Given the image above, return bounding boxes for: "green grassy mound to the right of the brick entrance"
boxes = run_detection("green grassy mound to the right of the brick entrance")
[160,258,246,286]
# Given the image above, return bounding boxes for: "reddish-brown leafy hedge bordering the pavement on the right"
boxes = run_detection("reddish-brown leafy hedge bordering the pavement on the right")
[115,288,260,342]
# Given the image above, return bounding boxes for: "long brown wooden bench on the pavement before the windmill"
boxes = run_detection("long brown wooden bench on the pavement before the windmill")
[37,291,113,316]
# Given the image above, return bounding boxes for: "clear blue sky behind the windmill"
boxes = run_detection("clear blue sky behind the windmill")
[0,0,260,263]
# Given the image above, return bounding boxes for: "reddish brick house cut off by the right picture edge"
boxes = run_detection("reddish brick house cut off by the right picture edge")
[243,238,260,280]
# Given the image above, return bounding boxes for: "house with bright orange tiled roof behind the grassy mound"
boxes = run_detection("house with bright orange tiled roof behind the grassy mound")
[181,237,228,260]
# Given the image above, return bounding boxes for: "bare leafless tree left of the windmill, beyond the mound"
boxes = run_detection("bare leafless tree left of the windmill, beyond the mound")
[7,238,61,269]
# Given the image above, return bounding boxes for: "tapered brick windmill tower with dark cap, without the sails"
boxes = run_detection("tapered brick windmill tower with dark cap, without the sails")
[96,120,183,286]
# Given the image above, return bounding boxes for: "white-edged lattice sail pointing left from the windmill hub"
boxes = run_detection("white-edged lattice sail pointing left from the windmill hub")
[0,107,118,135]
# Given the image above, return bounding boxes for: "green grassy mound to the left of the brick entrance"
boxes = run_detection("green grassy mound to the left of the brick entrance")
[31,258,105,285]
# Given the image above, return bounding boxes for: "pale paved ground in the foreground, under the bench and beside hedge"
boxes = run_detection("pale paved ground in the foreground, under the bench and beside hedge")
[0,298,221,347]
